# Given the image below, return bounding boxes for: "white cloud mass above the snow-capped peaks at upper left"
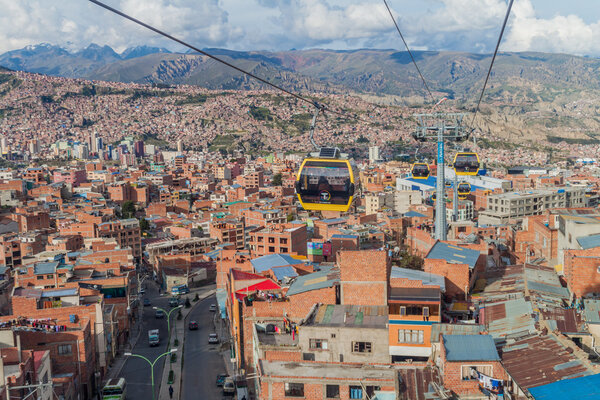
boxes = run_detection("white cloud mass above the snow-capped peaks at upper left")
[0,0,242,53]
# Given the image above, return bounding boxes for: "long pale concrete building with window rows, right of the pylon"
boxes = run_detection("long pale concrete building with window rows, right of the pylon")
[479,188,586,225]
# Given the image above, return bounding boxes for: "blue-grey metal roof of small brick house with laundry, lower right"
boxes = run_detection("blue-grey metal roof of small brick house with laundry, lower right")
[443,335,500,361]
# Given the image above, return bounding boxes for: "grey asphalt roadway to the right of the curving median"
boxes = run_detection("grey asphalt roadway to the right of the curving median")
[181,296,226,400]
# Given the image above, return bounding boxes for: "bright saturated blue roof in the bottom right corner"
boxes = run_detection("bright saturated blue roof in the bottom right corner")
[528,374,600,400]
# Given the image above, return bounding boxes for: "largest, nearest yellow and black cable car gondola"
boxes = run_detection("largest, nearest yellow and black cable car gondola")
[296,147,358,212]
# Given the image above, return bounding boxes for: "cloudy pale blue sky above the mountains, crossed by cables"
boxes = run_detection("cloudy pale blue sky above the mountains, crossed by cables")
[0,0,600,57]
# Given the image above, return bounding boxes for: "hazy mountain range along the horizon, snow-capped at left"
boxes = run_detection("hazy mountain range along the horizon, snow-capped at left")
[0,44,600,102]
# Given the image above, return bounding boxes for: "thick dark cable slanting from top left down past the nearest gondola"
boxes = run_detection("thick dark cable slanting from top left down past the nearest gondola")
[89,0,360,122]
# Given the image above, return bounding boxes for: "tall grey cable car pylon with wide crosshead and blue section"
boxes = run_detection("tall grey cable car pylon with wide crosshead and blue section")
[413,113,470,240]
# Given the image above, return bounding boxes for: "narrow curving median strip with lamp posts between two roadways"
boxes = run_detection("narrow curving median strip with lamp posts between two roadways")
[158,289,216,399]
